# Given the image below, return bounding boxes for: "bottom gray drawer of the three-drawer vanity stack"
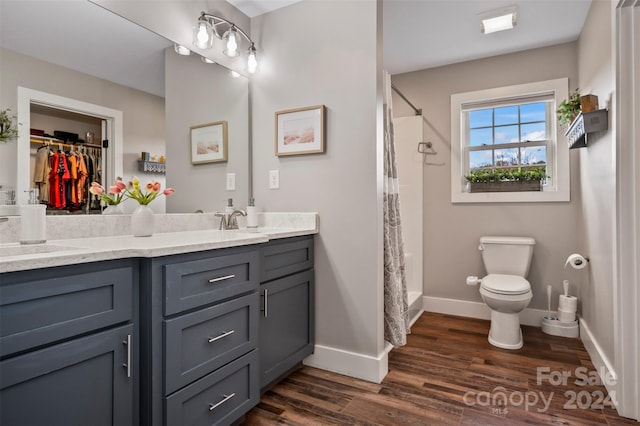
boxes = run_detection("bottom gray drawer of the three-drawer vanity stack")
[165,350,260,426]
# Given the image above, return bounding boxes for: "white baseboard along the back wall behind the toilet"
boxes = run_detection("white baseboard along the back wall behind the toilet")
[422,296,553,327]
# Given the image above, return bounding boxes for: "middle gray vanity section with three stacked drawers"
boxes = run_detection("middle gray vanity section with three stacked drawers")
[141,246,260,426]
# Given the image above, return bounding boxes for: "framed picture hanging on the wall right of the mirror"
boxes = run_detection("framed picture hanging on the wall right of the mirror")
[276,105,325,156]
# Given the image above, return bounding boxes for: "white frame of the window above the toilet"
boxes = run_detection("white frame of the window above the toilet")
[451,78,571,203]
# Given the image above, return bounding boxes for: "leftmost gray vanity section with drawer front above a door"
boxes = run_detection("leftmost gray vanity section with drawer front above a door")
[0,260,138,425]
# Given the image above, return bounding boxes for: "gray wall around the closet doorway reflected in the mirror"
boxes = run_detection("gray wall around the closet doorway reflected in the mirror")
[0,49,165,212]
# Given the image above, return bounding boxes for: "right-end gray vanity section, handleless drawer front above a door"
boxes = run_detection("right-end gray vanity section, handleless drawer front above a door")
[260,236,315,392]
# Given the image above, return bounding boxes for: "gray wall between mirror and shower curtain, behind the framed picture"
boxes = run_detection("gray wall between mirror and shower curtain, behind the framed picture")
[252,0,384,362]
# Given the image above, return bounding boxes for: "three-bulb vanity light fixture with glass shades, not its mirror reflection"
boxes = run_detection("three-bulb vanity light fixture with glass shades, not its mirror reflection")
[193,12,258,74]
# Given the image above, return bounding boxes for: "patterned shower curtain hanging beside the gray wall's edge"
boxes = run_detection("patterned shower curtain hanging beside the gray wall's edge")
[383,72,410,347]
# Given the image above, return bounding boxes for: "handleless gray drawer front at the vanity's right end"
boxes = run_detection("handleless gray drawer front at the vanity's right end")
[260,237,313,282]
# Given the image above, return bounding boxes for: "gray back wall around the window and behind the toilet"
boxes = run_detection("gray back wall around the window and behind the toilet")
[392,43,580,309]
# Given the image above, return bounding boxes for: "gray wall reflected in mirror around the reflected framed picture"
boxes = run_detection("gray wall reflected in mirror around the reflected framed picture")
[165,48,249,213]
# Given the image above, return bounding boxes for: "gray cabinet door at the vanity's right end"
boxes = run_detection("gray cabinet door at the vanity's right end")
[259,269,314,388]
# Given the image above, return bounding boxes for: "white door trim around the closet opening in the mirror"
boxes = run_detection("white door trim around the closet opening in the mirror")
[16,87,123,205]
